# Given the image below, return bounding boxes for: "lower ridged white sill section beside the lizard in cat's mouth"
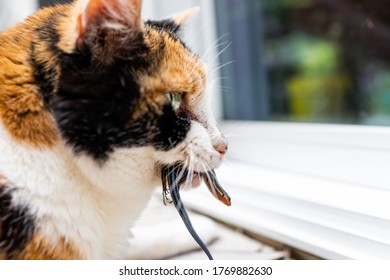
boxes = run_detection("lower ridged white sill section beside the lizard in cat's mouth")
[183,164,390,259]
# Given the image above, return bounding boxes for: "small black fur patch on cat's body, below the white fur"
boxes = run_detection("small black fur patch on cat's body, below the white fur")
[0,185,35,258]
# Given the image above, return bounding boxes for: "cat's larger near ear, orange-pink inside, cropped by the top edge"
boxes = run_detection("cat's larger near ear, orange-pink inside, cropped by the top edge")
[64,0,143,59]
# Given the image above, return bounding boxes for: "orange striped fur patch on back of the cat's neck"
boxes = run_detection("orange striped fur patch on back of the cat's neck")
[0,8,58,147]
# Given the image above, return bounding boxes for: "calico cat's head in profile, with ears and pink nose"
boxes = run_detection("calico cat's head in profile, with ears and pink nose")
[53,0,227,184]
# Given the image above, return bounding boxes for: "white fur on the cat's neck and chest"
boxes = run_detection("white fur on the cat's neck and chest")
[0,125,156,259]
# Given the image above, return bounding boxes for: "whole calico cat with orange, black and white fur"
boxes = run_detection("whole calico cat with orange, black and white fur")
[0,0,227,259]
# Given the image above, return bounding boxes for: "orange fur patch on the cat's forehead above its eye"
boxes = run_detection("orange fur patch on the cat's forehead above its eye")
[136,20,207,95]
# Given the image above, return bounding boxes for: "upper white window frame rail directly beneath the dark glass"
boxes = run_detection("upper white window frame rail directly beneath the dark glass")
[224,122,390,190]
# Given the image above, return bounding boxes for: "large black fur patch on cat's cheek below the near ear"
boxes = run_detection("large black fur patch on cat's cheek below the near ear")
[52,54,139,159]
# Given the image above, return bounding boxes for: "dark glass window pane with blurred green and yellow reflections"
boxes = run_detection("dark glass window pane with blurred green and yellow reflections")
[215,0,390,125]
